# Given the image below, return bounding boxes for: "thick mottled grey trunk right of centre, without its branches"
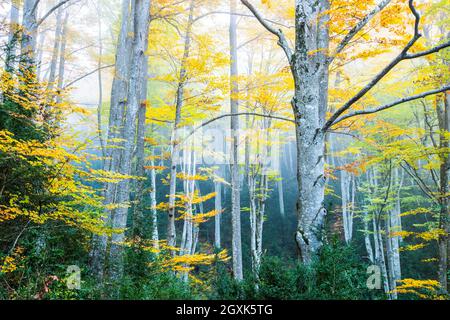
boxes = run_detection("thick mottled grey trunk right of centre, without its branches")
[291,0,329,264]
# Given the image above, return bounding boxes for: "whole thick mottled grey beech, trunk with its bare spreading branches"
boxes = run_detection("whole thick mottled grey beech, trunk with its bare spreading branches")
[241,0,450,263]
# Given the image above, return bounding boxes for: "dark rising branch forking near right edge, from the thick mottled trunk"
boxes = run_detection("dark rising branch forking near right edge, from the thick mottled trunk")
[322,0,449,132]
